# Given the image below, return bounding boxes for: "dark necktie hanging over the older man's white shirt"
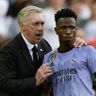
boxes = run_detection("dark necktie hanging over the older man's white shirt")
[32,46,39,66]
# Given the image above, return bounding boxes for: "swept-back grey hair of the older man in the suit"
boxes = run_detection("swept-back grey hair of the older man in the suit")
[17,5,43,25]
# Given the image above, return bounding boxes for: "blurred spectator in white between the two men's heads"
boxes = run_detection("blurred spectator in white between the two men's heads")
[44,0,65,49]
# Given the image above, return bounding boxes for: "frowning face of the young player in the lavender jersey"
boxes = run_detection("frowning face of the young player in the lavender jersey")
[56,17,76,44]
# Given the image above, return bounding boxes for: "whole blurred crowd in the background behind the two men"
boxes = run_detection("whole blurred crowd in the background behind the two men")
[0,0,96,49]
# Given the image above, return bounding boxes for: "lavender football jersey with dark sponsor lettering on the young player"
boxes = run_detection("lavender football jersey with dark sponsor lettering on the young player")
[43,45,96,96]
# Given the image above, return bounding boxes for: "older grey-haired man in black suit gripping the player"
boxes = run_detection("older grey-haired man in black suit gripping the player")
[0,6,52,96]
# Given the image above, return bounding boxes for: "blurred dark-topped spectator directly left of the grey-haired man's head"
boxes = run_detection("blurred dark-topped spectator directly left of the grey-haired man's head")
[7,0,32,38]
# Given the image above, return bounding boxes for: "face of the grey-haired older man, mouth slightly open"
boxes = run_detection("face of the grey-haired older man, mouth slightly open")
[22,13,44,44]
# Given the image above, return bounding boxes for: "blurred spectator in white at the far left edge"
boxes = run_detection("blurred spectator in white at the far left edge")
[0,0,9,48]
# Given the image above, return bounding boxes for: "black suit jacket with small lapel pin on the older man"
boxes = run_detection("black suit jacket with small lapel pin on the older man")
[0,34,51,96]
